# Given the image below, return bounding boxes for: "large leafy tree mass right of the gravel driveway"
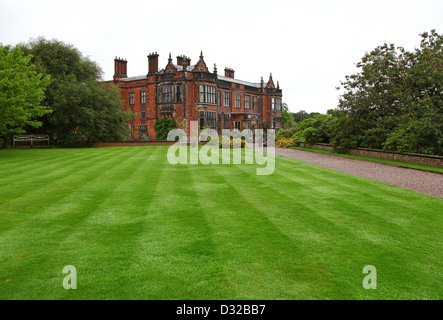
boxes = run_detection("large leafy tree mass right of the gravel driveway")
[331,30,443,154]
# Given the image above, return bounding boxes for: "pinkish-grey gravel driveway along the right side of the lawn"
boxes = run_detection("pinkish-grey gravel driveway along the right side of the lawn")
[275,148,443,199]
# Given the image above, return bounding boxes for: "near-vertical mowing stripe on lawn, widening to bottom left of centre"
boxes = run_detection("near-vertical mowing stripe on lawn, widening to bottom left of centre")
[118,158,224,299]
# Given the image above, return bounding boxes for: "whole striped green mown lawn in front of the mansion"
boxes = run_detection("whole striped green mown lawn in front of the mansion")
[0,147,443,299]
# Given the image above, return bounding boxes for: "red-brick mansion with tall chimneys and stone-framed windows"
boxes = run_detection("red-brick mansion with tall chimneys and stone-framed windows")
[108,53,282,140]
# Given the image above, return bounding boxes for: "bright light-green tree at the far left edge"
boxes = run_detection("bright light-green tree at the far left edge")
[0,45,49,145]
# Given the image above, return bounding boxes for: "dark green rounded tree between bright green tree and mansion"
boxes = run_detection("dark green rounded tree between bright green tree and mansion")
[20,38,131,143]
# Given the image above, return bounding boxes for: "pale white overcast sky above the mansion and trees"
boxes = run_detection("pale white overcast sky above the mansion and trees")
[0,0,443,113]
